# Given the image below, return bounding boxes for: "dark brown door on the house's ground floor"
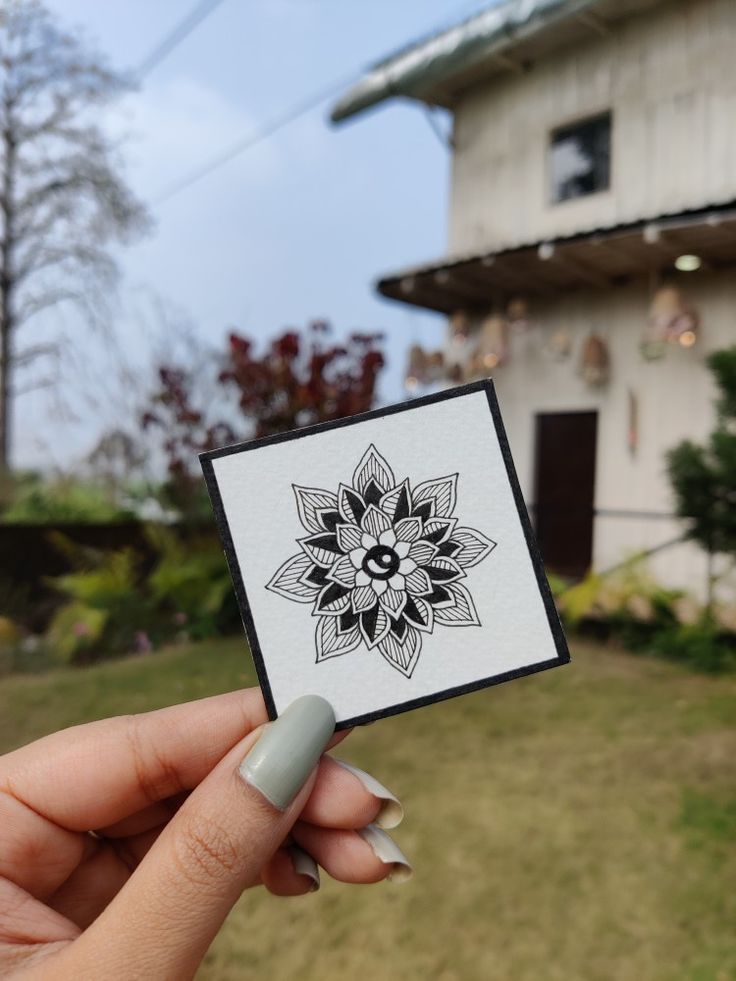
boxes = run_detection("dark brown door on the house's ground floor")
[534,412,598,577]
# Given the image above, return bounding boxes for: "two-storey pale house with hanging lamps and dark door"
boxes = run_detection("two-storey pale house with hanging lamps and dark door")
[332,0,736,595]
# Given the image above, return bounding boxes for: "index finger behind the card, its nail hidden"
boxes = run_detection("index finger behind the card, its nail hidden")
[0,688,267,831]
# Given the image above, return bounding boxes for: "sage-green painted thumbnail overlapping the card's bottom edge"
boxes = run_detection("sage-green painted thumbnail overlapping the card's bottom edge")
[239,695,335,811]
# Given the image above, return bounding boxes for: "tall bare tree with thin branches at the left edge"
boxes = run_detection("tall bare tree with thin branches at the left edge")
[0,0,148,481]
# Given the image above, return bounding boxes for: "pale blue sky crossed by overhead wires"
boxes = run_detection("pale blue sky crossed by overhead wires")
[14,0,492,467]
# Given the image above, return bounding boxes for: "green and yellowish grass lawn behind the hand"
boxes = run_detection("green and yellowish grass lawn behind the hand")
[0,640,736,981]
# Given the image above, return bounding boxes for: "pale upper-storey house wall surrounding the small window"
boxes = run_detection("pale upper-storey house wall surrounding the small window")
[450,0,736,253]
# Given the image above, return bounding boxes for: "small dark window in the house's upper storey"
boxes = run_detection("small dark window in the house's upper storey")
[550,112,611,204]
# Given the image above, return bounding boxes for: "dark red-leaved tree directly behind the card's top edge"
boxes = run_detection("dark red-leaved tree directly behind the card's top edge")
[142,321,385,514]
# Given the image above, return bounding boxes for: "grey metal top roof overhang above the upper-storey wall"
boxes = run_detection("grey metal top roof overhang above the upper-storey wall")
[330,0,659,122]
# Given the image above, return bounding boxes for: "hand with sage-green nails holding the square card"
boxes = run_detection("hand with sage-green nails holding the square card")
[0,689,410,981]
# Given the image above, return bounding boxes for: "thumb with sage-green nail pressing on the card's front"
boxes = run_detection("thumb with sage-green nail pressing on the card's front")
[63,695,335,979]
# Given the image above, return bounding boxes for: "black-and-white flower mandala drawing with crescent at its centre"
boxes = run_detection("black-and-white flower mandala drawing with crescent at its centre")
[266,445,496,678]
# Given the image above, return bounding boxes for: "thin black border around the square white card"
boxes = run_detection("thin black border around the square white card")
[199,378,570,730]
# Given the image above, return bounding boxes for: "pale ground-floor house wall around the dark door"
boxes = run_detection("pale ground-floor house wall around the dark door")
[472,273,736,597]
